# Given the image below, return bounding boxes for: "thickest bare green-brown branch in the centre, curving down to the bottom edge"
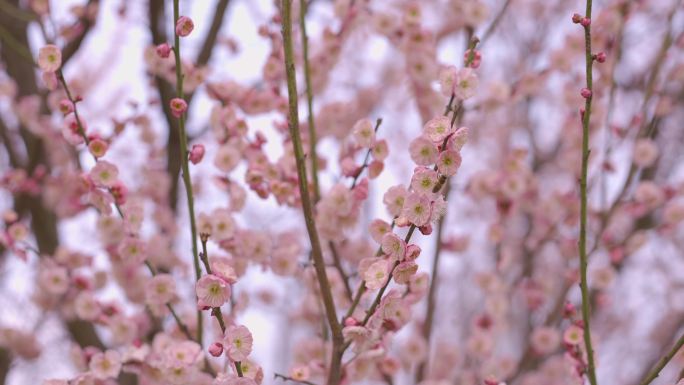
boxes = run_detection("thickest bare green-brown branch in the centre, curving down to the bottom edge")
[282,0,344,385]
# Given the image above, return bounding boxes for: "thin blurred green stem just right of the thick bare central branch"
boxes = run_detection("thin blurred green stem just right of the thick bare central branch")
[299,1,321,202]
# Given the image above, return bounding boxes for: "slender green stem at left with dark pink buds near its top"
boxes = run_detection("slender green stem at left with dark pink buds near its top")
[173,0,202,345]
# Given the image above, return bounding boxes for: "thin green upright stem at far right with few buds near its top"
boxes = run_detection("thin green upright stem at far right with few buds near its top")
[579,0,597,385]
